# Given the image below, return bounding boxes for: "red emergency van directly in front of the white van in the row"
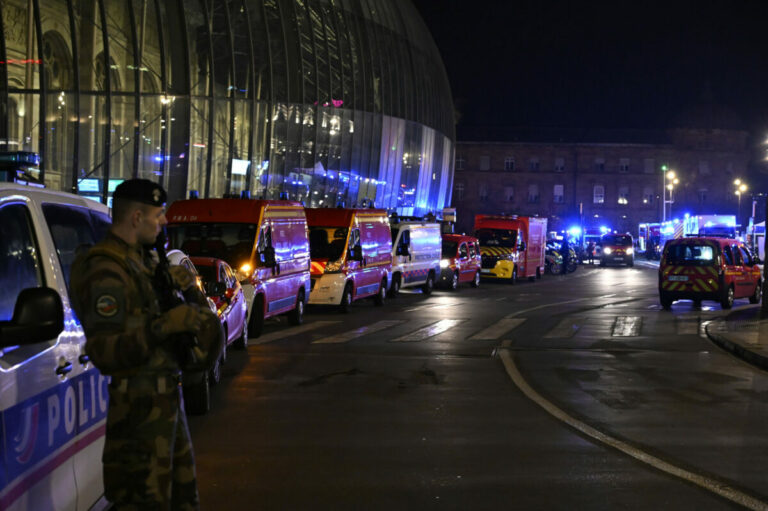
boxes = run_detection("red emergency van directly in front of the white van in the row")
[306,208,392,312]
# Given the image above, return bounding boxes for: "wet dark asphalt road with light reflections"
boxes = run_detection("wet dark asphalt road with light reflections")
[190,264,768,510]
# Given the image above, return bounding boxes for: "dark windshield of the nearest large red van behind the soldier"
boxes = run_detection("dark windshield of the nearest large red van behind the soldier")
[168,223,257,268]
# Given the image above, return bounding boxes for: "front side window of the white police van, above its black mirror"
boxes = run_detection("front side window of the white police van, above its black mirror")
[0,204,44,321]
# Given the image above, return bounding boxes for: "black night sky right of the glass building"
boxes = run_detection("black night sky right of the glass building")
[413,0,768,138]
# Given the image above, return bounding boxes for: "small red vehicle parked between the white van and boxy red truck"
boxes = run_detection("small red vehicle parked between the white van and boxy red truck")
[440,234,482,290]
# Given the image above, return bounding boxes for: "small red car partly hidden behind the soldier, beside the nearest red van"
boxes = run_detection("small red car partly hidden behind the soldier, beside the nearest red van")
[190,257,248,352]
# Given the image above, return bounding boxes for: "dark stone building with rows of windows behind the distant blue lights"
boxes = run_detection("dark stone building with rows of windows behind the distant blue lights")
[452,122,752,238]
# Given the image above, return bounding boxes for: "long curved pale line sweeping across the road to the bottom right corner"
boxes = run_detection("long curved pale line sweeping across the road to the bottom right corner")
[499,300,768,511]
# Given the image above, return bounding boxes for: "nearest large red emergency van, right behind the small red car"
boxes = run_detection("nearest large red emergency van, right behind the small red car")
[166,199,310,338]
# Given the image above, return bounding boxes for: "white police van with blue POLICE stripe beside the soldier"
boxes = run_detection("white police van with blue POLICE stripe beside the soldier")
[0,183,110,511]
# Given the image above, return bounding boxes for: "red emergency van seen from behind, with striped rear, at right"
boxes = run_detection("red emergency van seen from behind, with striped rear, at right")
[659,237,762,309]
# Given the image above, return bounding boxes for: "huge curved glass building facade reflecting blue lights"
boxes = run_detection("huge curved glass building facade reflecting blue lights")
[0,0,455,213]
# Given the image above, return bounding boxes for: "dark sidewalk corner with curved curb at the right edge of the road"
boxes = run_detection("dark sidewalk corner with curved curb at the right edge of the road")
[706,307,768,370]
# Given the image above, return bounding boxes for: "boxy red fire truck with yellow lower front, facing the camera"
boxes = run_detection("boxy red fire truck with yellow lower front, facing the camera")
[474,215,547,284]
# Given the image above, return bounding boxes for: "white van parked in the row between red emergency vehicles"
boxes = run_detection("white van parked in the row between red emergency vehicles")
[389,217,443,296]
